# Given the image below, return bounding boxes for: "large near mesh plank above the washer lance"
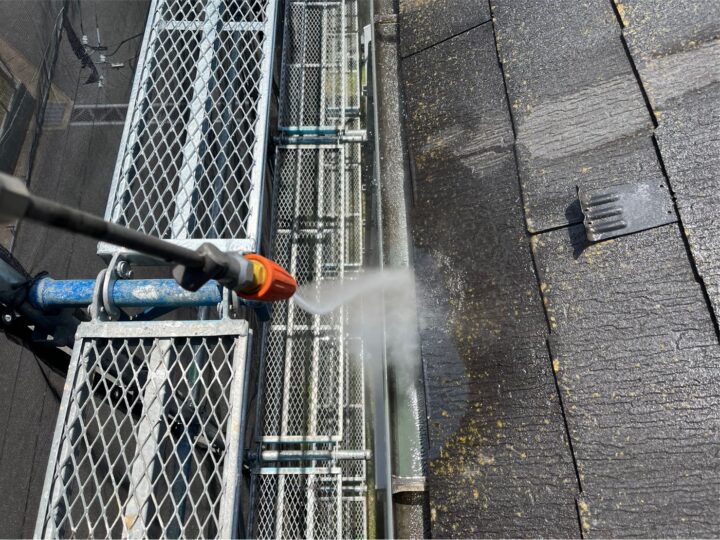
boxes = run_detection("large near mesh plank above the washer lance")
[99,0,276,254]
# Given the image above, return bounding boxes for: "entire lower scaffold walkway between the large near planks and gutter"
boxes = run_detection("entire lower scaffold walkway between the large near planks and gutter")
[250,0,369,538]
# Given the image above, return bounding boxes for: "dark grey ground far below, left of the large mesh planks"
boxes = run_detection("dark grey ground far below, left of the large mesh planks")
[0,0,149,537]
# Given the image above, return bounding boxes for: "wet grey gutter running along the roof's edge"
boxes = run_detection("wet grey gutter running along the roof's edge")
[373,0,428,538]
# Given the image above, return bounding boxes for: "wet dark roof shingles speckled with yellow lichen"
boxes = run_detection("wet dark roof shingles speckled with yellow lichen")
[400,0,720,537]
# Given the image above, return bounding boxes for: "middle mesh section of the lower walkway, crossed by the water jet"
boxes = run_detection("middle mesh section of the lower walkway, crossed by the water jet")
[262,146,345,442]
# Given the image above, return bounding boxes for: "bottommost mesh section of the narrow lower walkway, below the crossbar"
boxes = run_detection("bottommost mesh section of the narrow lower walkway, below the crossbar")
[253,467,343,538]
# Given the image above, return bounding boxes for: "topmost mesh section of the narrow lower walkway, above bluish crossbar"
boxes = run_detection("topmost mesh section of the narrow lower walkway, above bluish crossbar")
[279,0,347,135]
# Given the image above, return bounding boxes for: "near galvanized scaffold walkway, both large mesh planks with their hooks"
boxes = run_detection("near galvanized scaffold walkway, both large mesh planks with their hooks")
[36,0,276,538]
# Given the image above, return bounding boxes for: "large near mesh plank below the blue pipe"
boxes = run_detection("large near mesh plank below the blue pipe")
[36,320,248,538]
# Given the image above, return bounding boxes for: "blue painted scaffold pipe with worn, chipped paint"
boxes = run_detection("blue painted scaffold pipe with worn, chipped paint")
[28,278,222,310]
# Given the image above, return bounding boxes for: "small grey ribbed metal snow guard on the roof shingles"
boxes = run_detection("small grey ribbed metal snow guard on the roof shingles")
[578,182,677,242]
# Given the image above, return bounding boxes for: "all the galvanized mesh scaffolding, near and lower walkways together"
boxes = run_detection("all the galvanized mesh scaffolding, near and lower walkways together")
[36,0,370,538]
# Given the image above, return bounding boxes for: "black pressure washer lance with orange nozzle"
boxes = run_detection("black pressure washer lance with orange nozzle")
[0,173,297,302]
